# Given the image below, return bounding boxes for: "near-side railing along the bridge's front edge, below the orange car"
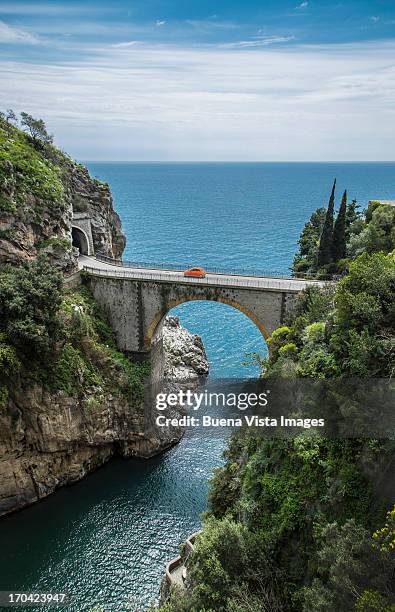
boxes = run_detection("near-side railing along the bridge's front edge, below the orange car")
[83,264,324,291]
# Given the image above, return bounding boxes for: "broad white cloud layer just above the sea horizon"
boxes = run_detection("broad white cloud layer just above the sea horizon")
[0,41,395,161]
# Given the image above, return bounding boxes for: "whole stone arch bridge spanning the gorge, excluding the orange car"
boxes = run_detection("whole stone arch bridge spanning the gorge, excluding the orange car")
[80,256,323,359]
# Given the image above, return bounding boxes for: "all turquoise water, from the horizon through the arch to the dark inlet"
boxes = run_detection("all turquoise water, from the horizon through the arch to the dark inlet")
[0,163,395,611]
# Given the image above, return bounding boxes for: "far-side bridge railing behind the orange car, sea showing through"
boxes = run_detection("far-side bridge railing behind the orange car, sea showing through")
[95,253,336,281]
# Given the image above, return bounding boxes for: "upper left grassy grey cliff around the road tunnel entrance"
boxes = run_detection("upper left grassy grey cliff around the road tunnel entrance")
[0,122,125,272]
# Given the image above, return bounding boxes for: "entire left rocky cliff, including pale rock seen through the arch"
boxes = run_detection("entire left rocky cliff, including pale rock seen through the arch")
[0,118,208,516]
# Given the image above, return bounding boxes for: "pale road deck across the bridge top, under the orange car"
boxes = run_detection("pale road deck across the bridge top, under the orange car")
[79,255,326,293]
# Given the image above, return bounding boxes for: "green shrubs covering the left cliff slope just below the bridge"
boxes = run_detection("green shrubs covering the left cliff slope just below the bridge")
[0,256,148,410]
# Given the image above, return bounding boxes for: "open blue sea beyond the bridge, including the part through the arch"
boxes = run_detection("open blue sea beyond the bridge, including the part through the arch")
[88,163,395,378]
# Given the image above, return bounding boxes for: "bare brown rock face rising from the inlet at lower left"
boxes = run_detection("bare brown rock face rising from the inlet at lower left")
[0,378,172,516]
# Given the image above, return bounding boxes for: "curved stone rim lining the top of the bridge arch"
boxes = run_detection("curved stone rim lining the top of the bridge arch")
[144,295,270,350]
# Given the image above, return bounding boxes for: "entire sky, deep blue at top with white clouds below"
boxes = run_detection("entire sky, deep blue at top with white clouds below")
[0,0,395,161]
